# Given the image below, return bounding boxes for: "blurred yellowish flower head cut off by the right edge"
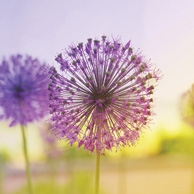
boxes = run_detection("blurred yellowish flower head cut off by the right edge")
[181,84,194,126]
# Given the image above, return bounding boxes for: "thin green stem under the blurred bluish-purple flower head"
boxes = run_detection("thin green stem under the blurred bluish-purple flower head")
[21,125,33,194]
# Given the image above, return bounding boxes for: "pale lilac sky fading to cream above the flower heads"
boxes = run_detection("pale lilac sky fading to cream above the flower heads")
[0,0,194,146]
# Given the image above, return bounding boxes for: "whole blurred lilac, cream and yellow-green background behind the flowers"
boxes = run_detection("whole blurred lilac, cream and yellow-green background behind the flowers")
[0,0,194,194]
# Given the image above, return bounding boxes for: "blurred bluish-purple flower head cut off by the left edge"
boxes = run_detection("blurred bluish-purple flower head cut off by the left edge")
[0,55,49,126]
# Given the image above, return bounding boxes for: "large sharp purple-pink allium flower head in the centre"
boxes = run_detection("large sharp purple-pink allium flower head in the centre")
[48,36,160,153]
